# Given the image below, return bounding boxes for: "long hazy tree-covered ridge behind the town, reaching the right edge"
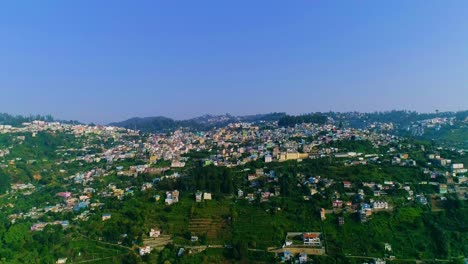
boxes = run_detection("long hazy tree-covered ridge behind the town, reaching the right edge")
[109,110,468,133]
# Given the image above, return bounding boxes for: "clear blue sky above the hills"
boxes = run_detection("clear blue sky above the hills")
[0,0,468,123]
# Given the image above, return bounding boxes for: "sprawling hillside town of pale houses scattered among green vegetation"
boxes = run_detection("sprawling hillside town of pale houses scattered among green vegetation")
[0,120,468,263]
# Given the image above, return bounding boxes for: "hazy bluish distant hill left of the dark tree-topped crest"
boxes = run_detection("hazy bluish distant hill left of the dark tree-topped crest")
[109,113,286,133]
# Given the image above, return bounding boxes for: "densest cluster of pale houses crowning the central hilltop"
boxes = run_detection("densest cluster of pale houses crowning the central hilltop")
[143,119,398,168]
